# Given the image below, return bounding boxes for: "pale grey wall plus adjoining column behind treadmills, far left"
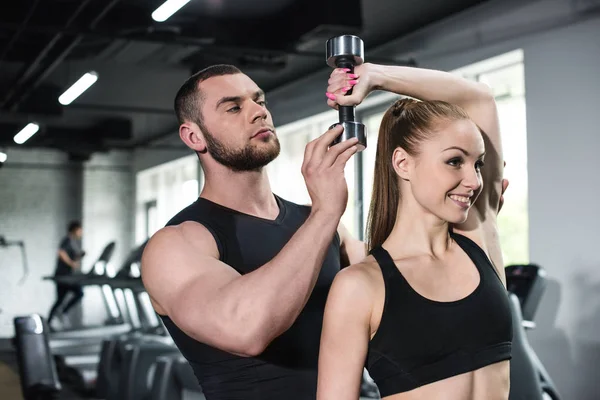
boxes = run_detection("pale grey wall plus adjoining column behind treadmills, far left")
[0,149,134,338]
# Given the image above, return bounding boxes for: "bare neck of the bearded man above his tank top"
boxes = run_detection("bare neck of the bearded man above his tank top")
[200,168,279,220]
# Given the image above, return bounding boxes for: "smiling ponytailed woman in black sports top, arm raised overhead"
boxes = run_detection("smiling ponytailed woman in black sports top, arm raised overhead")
[317,64,512,400]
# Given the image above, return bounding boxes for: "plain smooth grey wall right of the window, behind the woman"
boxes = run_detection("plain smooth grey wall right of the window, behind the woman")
[525,19,600,399]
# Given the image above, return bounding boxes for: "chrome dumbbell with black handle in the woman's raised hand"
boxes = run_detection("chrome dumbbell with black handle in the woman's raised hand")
[327,35,367,151]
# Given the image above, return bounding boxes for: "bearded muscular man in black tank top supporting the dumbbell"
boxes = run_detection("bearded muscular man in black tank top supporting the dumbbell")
[142,65,506,400]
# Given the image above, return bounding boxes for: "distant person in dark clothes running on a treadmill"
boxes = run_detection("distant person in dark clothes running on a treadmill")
[48,221,85,327]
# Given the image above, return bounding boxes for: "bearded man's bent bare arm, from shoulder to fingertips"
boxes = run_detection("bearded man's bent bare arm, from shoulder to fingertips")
[142,128,356,356]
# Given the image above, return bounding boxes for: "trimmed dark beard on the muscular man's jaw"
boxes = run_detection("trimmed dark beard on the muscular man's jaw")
[203,129,281,172]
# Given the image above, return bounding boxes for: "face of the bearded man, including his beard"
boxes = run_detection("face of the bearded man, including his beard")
[199,74,280,171]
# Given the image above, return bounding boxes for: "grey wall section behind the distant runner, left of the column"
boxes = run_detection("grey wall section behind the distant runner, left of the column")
[0,149,83,337]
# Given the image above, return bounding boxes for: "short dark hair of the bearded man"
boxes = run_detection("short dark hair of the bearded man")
[175,64,242,127]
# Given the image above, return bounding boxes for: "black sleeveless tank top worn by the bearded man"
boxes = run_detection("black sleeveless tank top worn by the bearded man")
[161,196,340,400]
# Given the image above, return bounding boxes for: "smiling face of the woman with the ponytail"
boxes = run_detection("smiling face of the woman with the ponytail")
[409,120,485,224]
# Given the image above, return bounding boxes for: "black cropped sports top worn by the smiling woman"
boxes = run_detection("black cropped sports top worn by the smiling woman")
[367,233,512,397]
